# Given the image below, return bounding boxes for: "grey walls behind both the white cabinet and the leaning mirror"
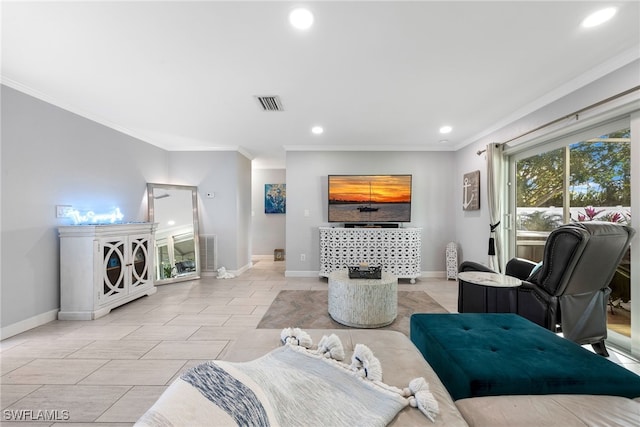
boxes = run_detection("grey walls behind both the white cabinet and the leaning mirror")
[0,86,251,337]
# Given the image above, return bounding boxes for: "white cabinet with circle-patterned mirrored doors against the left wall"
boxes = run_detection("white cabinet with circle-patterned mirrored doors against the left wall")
[58,223,157,320]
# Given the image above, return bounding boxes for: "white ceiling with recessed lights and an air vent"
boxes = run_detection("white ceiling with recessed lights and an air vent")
[1,1,640,168]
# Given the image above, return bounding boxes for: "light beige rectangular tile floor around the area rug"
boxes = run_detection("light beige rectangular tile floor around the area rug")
[0,260,640,427]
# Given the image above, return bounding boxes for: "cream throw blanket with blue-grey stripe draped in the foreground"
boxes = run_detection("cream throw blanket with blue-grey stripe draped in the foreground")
[136,344,437,427]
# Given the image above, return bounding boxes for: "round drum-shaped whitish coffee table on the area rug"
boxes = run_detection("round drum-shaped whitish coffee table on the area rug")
[329,270,398,328]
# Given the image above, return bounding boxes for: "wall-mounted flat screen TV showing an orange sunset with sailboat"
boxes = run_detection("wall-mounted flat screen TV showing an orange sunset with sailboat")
[328,175,411,223]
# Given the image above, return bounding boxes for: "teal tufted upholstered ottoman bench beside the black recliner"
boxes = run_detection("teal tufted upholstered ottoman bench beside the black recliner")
[410,313,640,400]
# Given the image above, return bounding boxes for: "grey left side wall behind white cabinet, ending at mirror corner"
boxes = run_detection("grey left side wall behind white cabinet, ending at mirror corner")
[0,86,167,335]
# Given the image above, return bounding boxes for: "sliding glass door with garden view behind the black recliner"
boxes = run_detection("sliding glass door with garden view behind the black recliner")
[510,122,640,347]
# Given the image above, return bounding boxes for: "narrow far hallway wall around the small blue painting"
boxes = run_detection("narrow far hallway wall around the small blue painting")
[251,169,287,256]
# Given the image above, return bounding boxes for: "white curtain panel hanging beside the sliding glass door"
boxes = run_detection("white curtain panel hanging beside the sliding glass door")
[487,144,507,273]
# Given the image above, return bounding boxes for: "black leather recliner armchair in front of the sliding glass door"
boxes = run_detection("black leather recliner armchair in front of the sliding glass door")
[460,221,635,356]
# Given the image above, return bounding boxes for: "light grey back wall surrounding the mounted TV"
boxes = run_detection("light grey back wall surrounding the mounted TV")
[286,151,462,276]
